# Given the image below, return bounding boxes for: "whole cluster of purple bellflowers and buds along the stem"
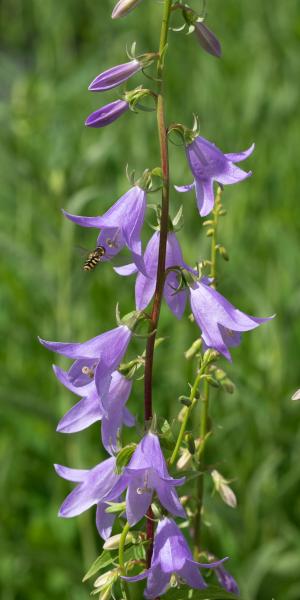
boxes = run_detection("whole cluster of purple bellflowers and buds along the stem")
[40,0,272,599]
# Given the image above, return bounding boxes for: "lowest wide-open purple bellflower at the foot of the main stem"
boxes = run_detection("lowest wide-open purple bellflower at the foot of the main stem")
[124,518,226,600]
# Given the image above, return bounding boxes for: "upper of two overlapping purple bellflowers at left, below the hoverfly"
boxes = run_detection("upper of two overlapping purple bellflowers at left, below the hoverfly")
[39,325,132,397]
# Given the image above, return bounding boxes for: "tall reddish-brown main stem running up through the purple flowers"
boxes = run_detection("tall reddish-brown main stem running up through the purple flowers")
[144,0,172,565]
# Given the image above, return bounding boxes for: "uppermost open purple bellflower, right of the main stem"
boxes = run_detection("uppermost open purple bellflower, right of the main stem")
[175,136,254,217]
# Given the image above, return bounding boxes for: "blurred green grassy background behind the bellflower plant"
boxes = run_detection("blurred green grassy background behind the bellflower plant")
[0,0,300,600]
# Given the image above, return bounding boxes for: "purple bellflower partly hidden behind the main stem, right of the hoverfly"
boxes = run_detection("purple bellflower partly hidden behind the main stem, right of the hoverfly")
[115,231,191,319]
